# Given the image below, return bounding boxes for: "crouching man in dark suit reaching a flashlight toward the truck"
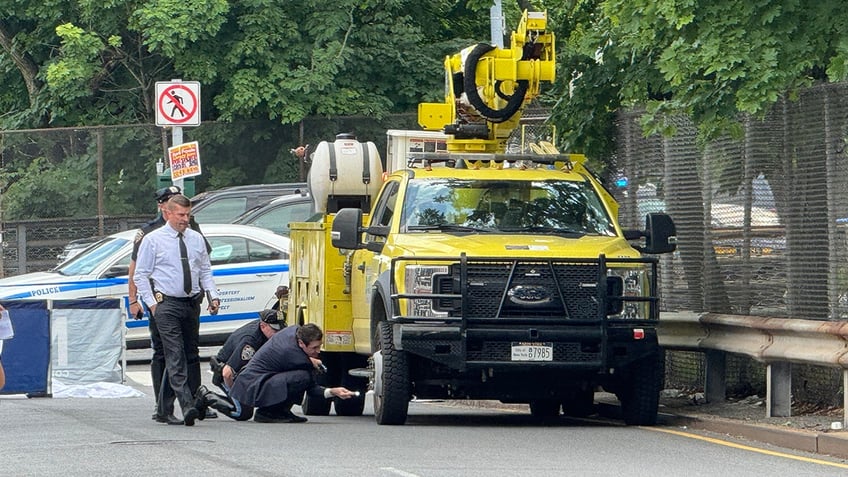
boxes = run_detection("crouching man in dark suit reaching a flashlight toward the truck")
[230,323,356,423]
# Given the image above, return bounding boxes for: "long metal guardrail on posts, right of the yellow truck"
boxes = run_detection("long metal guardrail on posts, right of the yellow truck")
[658,312,848,427]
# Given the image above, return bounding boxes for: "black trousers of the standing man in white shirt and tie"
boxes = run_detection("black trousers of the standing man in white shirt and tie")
[155,297,200,415]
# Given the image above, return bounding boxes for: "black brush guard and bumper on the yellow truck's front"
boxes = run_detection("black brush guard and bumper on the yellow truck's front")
[389,254,659,375]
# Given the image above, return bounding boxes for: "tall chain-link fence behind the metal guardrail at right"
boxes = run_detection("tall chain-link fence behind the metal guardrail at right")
[614,84,848,403]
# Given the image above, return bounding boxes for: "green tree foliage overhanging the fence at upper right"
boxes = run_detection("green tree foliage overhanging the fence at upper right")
[552,0,848,162]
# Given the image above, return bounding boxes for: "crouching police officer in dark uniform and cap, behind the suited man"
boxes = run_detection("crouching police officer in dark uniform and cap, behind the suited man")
[194,310,285,421]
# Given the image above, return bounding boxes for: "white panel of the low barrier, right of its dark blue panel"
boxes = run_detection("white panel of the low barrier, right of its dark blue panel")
[50,299,124,384]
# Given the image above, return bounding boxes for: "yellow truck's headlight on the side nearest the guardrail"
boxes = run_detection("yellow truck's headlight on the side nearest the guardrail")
[607,268,651,320]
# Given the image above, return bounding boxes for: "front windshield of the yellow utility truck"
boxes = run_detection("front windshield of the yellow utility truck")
[403,179,615,236]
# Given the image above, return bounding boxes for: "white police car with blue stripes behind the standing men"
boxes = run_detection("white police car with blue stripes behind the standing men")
[0,224,289,348]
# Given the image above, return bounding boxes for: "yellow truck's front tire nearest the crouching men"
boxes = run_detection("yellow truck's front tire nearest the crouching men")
[374,321,410,425]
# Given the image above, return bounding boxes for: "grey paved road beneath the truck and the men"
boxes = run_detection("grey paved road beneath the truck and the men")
[0,352,848,477]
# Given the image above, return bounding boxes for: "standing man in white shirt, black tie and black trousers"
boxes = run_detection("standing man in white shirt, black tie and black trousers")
[133,195,221,426]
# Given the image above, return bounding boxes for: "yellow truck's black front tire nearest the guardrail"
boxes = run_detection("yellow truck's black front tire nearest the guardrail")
[617,350,665,426]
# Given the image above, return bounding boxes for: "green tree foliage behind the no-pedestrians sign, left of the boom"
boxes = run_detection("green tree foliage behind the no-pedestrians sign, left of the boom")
[0,0,488,215]
